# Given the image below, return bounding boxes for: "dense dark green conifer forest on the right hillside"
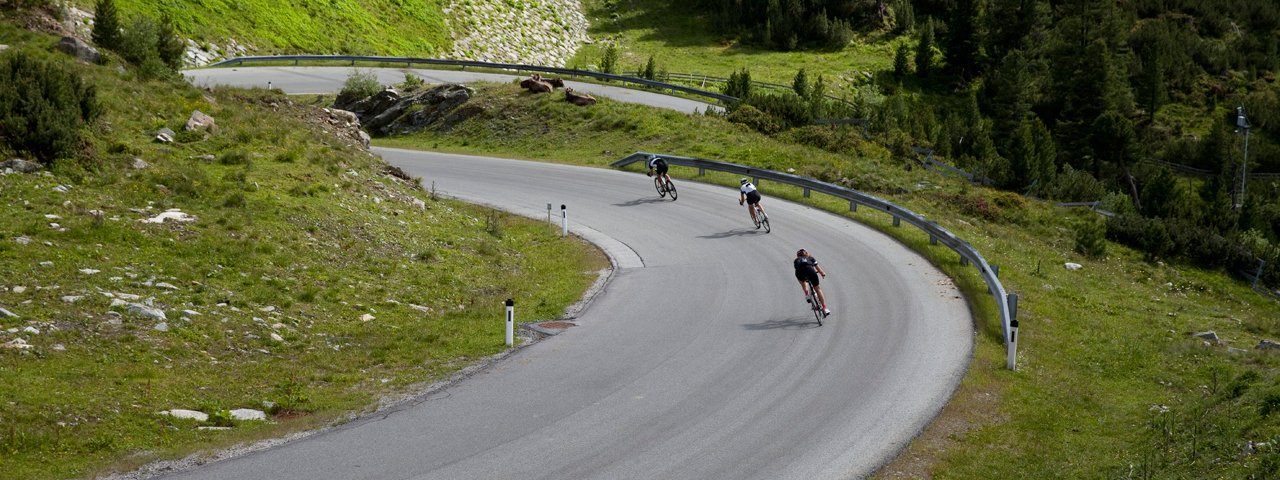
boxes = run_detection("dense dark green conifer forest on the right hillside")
[684,0,1280,287]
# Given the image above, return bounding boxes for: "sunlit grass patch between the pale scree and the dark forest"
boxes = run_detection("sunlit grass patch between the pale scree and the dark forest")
[567,0,897,88]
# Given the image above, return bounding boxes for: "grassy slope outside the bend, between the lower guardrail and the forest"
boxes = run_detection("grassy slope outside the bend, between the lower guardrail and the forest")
[380,84,1280,479]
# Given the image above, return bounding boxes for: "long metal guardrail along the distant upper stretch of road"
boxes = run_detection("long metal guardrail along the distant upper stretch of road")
[209,55,737,104]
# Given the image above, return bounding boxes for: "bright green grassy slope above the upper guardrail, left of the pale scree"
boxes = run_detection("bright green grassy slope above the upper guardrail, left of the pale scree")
[78,0,453,56]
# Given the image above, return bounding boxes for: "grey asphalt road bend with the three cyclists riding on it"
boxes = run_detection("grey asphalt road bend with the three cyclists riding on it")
[162,68,973,480]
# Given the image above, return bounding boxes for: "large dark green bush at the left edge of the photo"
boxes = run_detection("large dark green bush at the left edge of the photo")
[0,50,101,161]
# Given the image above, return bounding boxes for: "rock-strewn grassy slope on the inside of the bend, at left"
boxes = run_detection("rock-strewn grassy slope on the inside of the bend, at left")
[0,23,607,479]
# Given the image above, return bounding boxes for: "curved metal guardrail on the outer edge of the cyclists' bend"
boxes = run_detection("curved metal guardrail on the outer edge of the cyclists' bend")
[612,152,1018,370]
